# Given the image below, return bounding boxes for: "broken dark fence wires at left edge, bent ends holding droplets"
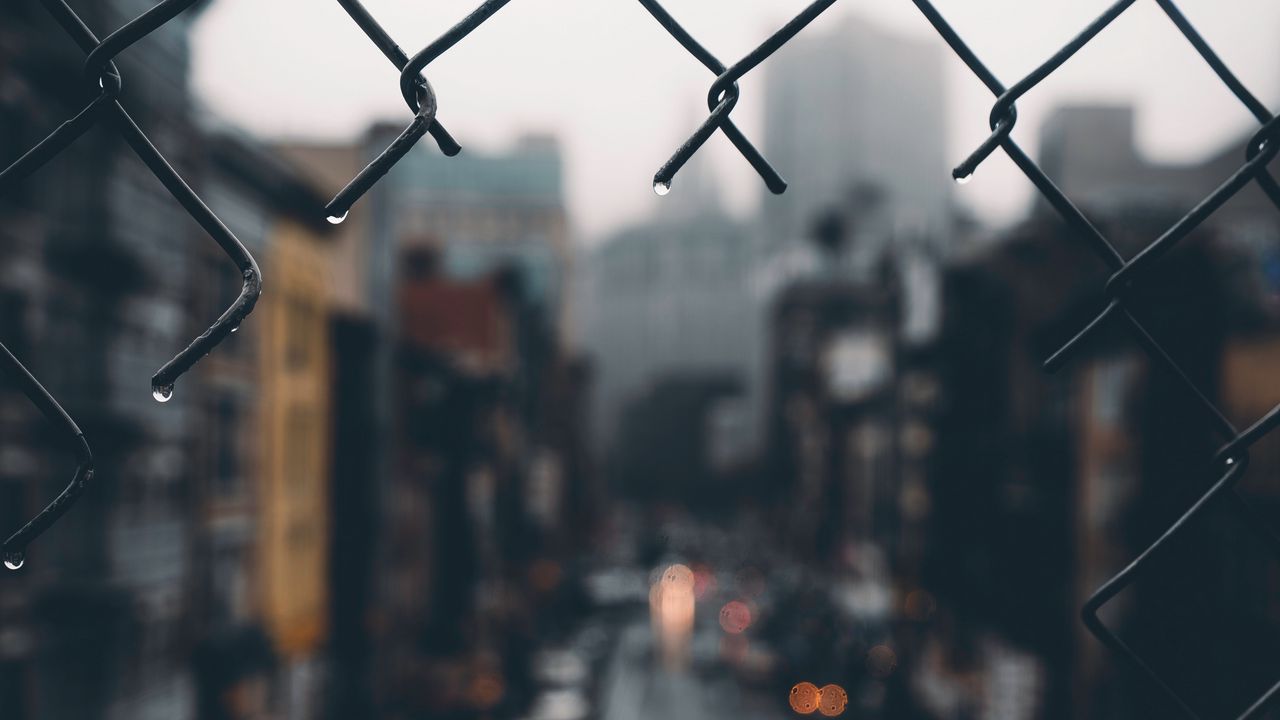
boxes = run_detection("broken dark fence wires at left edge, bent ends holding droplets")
[0,0,262,561]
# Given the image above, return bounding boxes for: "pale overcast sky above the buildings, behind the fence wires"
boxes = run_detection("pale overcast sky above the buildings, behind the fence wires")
[195,0,1280,242]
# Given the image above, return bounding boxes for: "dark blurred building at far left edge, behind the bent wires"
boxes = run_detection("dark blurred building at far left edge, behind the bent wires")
[0,0,212,720]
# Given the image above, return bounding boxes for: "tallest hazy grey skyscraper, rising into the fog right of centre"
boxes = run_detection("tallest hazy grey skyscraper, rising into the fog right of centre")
[762,18,951,264]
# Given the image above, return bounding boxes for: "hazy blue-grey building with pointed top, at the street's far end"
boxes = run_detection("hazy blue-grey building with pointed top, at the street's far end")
[580,159,762,461]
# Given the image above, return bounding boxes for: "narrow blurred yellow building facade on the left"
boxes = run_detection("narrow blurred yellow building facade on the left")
[253,218,333,657]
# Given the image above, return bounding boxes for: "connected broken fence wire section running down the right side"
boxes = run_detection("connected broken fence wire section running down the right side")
[911,0,1280,720]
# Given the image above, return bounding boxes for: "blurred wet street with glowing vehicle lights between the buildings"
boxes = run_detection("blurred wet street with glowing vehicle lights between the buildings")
[540,512,892,720]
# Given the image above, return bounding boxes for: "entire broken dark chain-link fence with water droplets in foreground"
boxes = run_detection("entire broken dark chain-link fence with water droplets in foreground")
[0,0,1280,719]
